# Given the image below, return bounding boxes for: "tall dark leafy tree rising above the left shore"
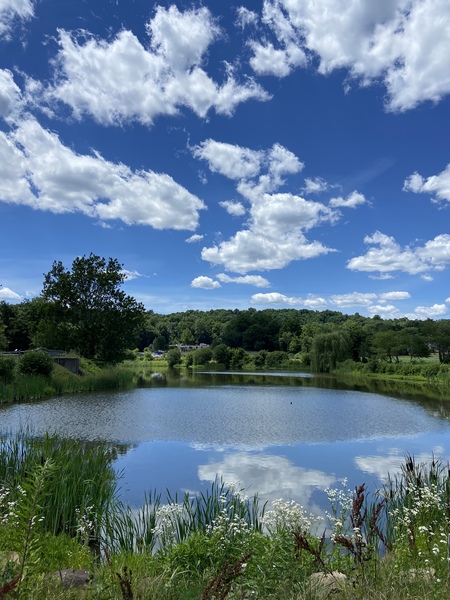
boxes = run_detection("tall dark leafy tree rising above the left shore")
[39,253,145,362]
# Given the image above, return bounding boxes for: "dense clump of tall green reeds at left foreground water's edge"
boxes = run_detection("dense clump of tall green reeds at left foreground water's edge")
[0,431,117,542]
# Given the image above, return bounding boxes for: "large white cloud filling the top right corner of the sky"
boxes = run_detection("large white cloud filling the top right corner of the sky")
[250,0,450,111]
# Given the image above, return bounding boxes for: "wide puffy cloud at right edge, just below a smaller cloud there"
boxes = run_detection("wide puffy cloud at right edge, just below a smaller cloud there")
[347,231,450,275]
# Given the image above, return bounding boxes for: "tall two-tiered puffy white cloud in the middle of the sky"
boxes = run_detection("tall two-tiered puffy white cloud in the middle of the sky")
[193,139,339,274]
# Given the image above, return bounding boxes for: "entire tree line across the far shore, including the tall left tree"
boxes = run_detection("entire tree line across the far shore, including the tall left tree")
[0,254,450,372]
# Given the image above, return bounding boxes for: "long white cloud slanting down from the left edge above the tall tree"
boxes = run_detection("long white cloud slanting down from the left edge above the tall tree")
[0,118,205,230]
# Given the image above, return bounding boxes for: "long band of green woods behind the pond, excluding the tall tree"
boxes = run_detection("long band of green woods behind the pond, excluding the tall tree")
[0,297,450,372]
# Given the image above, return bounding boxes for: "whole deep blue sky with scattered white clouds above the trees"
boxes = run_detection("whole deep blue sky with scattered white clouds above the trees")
[0,0,450,319]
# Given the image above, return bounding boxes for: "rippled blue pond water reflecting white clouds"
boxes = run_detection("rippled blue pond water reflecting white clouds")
[0,373,450,513]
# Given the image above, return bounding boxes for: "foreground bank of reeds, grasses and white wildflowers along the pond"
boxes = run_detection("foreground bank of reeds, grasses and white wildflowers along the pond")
[0,433,450,600]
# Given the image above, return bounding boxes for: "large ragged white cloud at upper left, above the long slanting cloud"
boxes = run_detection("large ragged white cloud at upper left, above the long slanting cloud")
[46,5,269,125]
